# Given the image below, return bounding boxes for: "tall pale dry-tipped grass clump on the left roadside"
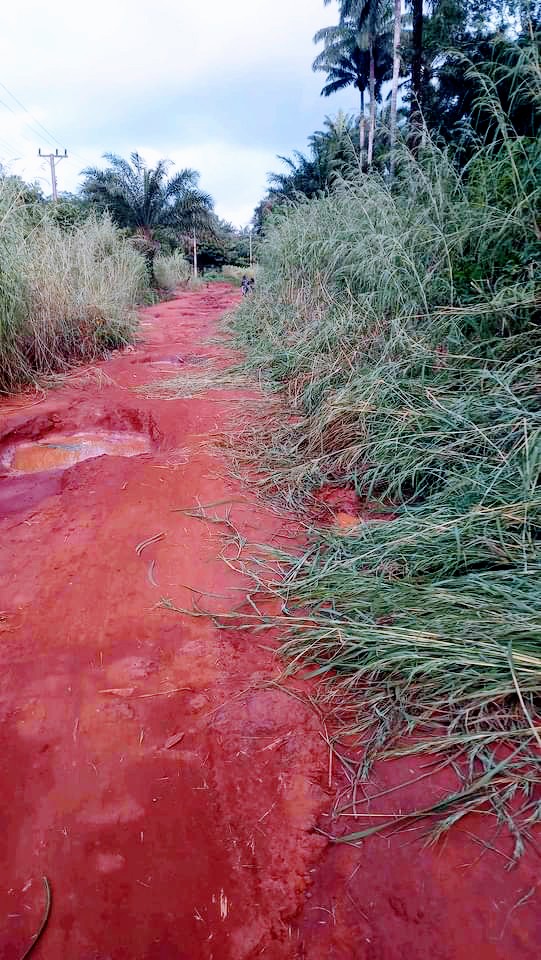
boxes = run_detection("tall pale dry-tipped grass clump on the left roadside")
[0,180,148,392]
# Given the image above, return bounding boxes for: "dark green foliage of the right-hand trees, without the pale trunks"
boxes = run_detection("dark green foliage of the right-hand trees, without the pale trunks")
[260,0,541,210]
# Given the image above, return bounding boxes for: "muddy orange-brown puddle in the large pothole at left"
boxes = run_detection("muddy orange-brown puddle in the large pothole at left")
[2,432,150,473]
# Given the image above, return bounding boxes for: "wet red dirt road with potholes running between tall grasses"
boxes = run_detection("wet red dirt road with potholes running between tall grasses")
[0,285,539,960]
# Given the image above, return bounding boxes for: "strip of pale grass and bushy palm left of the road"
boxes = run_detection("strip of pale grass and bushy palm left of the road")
[0,153,249,393]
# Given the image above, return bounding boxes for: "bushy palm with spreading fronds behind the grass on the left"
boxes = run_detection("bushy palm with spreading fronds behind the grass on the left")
[82,153,214,272]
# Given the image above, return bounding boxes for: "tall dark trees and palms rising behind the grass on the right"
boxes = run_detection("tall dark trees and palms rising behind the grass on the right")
[254,0,541,221]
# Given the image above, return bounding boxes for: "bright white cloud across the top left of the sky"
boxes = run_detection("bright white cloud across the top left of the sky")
[0,0,338,100]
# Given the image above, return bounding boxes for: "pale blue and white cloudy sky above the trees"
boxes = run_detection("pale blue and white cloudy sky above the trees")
[0,0,357,225]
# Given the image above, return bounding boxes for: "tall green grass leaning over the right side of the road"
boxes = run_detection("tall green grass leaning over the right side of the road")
[225,54,541,840]
